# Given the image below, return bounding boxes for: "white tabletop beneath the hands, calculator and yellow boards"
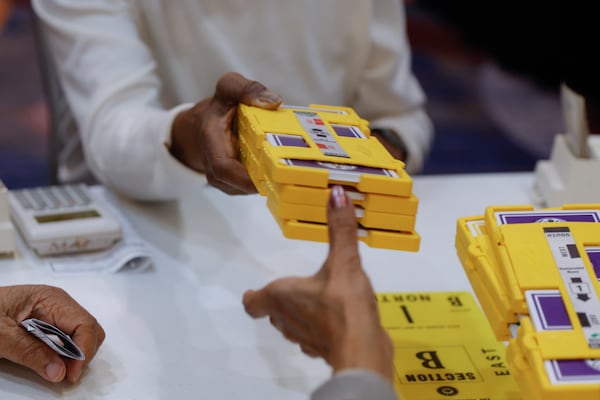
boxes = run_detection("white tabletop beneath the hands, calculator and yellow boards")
[0,173,533,400]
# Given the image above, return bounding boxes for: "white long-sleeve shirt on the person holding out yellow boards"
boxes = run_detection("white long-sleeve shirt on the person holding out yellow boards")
[33,0,432,200]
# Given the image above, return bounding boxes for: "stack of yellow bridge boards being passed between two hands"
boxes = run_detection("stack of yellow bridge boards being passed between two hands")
[237,104,420,251]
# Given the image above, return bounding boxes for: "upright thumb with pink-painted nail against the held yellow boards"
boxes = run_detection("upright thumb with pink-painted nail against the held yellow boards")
[327,185,358,255]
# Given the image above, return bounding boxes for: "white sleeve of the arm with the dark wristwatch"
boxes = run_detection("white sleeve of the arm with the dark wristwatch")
[354,1,433,173]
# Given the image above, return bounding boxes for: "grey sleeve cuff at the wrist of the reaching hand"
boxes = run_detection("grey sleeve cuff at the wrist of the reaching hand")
[311,369,400,400]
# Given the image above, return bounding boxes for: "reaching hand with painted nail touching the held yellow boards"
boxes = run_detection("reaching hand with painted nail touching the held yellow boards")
[244,186,393,380]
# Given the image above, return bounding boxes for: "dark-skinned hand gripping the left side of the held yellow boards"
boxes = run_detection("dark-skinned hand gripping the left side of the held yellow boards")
[171,72,282,194]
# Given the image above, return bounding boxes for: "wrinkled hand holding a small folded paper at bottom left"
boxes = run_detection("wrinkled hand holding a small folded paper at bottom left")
[0,285,104,382]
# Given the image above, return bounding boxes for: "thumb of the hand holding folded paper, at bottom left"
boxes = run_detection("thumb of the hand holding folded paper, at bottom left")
[0,327,67,382]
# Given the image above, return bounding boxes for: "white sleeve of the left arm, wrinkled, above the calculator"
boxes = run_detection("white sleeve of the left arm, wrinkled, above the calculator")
[32,0,205,200]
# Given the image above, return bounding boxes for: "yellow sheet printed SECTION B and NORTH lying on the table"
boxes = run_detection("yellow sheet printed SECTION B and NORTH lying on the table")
[377,292,529,400]
